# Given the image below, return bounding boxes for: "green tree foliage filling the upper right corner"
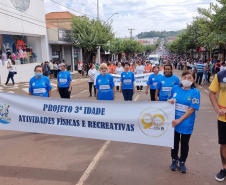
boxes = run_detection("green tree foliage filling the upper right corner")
[165,0,226,53]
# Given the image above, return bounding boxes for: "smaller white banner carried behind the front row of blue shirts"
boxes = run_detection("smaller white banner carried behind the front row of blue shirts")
[94,71,163,86]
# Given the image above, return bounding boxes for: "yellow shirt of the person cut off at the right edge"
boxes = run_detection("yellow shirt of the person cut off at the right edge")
[209,70,226,122]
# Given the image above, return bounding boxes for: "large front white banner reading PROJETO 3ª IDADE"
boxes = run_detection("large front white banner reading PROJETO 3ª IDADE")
[0,93,175,147]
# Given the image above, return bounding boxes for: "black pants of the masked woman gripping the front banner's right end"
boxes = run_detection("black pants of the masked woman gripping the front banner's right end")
[171,131,191,162]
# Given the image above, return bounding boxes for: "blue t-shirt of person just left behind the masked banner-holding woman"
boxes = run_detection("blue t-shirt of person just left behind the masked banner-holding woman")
[156,75,180,101]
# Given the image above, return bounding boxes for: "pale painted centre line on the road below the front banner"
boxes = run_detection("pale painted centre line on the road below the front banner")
[76,140,111,185]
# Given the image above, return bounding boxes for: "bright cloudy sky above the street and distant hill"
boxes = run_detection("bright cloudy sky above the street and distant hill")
[45,0,216,38]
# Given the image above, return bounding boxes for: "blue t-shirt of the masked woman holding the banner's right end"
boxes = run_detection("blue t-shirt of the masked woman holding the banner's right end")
[169,85,200,134]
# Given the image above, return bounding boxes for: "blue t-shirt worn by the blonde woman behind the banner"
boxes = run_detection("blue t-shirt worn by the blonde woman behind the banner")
[95,73,115,100]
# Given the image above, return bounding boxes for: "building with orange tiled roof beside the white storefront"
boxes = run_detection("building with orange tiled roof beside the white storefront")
[45,12,82,71]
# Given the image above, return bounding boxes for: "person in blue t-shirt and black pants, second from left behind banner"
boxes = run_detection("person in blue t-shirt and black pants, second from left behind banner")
[57,63,72,99]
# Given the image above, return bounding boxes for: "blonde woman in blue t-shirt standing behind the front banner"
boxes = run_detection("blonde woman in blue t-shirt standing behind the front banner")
[95,63,115,100]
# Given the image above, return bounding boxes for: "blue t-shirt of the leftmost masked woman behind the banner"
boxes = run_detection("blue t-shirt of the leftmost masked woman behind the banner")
[29,75,52,97]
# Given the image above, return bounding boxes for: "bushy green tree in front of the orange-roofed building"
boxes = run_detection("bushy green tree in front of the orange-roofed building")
[69,16,114,63]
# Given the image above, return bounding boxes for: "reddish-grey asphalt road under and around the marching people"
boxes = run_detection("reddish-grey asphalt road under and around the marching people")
[0,70,222,185]
